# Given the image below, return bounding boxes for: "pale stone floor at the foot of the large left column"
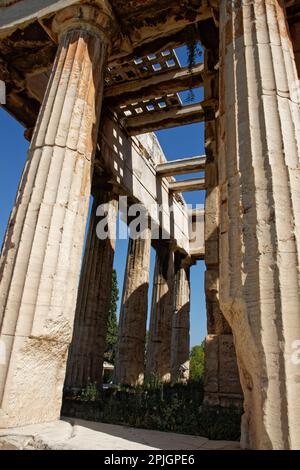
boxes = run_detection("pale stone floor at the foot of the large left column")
[0,418,240,450]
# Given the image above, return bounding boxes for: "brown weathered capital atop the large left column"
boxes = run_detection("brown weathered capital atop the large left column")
[52,0,117,44]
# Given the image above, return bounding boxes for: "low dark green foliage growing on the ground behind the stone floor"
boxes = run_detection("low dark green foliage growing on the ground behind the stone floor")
[62,381,242,440]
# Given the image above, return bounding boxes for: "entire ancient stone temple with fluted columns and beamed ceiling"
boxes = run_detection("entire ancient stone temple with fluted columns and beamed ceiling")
[0,0,300,449]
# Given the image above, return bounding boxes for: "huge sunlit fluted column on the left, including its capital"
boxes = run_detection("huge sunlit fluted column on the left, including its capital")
[0,2,116,428]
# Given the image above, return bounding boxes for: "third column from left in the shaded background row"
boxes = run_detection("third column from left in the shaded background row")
[146,241,174,382]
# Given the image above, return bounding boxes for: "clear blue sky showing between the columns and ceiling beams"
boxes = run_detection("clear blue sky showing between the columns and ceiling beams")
[0,48,206,346]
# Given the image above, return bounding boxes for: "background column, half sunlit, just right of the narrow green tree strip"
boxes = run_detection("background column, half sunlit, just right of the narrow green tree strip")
[114,230,151,385]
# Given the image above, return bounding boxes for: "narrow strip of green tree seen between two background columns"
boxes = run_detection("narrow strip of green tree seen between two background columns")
[105,269,119,363]
